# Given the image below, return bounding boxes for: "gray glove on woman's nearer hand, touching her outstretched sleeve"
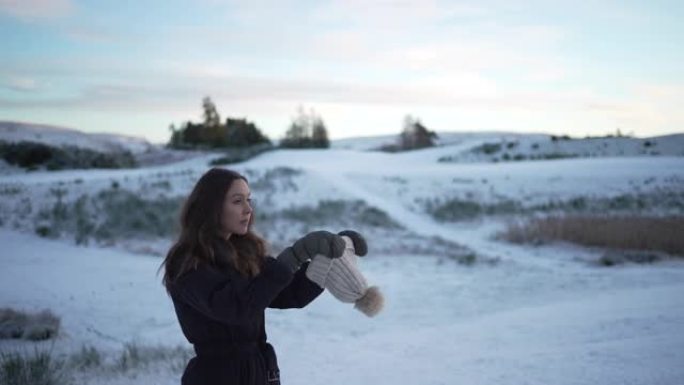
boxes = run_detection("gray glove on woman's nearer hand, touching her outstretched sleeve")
[278,230,345,272]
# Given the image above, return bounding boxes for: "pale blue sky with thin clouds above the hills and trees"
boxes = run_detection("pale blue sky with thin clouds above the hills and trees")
[0,0,684,142]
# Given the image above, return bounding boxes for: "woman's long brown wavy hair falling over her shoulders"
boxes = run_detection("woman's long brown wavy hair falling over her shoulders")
[159,168,266,290]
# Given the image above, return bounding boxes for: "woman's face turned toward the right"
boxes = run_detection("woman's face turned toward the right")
[221,179,252,238]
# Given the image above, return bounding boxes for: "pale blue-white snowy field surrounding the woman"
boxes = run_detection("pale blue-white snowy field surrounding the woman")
[0,133,684,385]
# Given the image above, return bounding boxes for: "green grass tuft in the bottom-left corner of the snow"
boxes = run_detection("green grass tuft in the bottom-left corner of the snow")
[0,351,66,385]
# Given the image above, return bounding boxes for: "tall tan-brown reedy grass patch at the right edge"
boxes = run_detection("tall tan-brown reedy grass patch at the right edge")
[499,216,684,259]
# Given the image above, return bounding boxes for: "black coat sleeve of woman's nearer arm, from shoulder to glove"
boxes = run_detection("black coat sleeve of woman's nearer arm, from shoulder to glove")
[171,258,293,325]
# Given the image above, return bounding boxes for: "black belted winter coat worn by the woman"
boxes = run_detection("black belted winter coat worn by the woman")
[169,243,323,385]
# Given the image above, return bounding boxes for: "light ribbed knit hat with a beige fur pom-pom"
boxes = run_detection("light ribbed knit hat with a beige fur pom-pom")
[306,236,384,317]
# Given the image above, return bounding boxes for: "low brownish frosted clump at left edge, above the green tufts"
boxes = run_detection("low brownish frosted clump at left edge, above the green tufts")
[0,308,60,341]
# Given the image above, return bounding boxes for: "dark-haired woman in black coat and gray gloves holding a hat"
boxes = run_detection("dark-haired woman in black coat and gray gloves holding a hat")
[162,168,352,385]
